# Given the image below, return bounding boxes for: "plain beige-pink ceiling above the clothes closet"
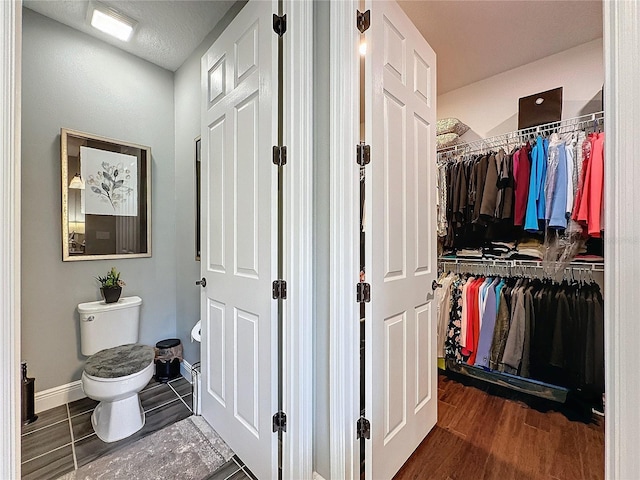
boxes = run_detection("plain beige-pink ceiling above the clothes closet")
[399,0,602,95]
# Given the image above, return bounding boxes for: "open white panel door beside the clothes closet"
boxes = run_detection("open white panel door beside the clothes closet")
[365,1,437,479]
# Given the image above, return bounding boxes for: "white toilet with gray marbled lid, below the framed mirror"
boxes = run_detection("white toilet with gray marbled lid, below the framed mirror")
[78,297,155,442]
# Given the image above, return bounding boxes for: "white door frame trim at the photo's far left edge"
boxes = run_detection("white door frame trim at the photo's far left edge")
[0,0,22,478]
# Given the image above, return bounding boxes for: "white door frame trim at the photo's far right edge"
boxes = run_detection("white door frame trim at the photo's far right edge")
[603,0,640,479]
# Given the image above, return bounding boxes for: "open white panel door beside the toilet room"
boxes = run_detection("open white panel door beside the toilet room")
[201,0,278,479]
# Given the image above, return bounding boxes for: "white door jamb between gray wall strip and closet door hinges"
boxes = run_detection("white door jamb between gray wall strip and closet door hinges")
[326,0,360,480]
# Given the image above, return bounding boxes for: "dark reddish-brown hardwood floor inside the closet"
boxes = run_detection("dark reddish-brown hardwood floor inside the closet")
[395,373,604,480]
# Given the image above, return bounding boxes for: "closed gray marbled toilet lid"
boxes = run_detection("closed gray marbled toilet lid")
[84,344,155,378]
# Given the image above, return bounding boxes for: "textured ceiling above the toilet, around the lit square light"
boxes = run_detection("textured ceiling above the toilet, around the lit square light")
[22,0,235,71]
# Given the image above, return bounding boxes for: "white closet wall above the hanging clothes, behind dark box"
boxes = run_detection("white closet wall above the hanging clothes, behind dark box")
[437,38,604,141]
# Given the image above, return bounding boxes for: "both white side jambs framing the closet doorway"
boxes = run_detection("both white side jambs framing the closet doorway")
[329,0,640,479]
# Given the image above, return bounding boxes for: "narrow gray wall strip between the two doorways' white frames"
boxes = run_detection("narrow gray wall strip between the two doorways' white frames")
[313,1,331,479]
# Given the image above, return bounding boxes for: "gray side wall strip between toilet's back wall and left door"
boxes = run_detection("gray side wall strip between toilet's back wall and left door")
[174,0,246,364]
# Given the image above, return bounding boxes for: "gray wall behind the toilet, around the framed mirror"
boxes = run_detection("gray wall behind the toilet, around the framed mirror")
[21,9,176,391]
